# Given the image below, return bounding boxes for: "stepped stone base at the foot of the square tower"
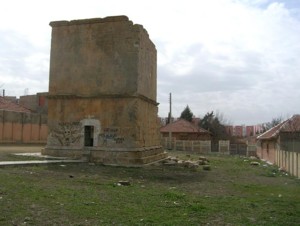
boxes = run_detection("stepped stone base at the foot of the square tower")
[42,146,167,166]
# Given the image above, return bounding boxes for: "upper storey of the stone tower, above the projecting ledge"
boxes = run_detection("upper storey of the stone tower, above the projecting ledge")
[49,16,156,100]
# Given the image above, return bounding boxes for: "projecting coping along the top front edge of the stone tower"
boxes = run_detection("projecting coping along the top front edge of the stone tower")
[49,15,132,27]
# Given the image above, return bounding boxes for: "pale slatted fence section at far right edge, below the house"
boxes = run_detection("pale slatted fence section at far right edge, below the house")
[275,149,300,178]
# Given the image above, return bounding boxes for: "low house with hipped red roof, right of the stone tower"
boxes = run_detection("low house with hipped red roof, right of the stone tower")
[160,118,211,140]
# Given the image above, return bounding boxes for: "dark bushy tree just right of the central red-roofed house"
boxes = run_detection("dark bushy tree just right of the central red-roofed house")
[199,111,229,140]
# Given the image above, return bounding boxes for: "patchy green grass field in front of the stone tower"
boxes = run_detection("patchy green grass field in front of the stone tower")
[0,152,300,226]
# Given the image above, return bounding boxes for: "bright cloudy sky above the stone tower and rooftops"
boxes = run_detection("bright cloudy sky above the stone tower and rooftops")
[0,0,300,125]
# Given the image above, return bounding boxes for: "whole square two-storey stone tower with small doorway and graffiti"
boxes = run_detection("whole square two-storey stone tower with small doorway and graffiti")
[42,16,166,165]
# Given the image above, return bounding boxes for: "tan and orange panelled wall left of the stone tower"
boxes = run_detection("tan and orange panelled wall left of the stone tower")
[0,110,48,144]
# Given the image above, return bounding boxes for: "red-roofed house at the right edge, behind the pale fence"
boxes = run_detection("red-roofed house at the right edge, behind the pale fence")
[256,115,300,163]
